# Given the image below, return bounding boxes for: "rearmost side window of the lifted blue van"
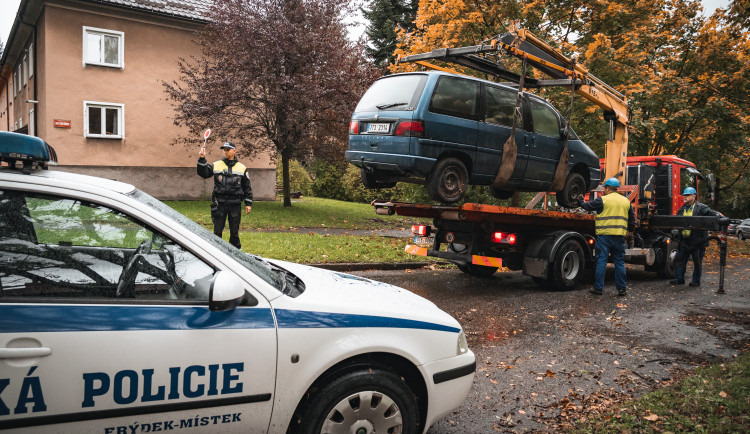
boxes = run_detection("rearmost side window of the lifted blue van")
[430,77,479,118]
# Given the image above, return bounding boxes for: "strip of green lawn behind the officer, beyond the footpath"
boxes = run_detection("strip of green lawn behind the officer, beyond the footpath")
[165,197,426,231]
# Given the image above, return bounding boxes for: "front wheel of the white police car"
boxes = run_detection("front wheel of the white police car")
[294,369,419,434]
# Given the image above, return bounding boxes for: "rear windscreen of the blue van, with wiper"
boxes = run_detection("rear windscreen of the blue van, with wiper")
[354,74,427,112]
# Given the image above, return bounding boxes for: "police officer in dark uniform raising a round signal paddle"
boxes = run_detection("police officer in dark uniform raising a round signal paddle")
[198,142,253,249]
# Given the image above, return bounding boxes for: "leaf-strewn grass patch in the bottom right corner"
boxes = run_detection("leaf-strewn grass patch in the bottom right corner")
[573,354,750,433]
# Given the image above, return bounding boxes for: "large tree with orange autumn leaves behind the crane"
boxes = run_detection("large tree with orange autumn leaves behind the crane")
[391,0,750,216]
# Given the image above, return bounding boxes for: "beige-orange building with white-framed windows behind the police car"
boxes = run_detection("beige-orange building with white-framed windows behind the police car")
[0,0,276,200]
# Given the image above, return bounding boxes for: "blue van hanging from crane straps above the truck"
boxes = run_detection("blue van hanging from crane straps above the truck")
[346,72,601,206]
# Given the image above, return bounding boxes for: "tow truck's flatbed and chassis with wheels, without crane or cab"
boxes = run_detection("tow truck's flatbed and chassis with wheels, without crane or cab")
[372,195,728,293]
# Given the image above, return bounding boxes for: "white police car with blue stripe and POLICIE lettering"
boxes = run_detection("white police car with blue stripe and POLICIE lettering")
[0,133,475,434]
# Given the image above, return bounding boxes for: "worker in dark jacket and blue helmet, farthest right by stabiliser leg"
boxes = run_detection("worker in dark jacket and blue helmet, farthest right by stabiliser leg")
[669,187,724,286]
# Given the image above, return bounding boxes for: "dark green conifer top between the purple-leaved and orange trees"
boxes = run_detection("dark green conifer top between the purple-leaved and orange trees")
[362,0,419,66]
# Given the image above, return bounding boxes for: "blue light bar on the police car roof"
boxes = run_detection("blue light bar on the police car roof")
[0,131,57,173]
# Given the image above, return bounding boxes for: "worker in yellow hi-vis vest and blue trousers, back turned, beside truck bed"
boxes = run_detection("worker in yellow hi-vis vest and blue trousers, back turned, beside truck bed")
[578,178,635,295]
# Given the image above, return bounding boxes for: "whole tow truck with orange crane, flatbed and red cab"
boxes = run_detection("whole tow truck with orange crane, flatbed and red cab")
[372,24,729,293]
